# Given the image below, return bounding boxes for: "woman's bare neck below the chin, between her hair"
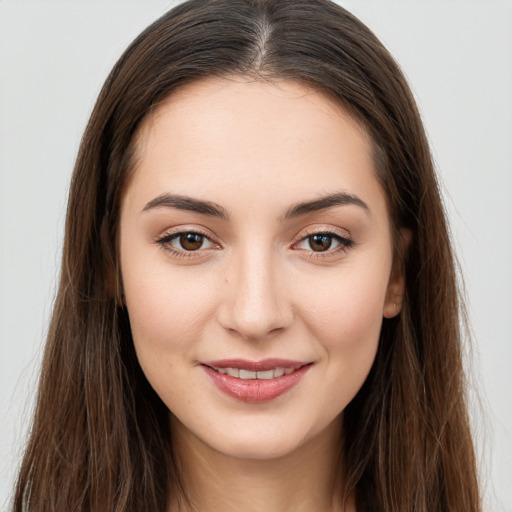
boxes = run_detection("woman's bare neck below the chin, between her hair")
[170,419,355,512]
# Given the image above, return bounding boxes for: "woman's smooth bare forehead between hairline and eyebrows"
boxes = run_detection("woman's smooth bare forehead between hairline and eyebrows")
[126,78,388,220]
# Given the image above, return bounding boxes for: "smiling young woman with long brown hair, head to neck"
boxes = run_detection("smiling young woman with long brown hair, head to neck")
[15,0,480,512]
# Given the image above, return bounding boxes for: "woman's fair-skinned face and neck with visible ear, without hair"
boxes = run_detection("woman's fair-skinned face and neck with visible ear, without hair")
[120,78,403,512]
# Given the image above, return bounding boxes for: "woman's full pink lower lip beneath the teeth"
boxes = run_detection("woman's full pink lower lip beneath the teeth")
[203,365,311,403]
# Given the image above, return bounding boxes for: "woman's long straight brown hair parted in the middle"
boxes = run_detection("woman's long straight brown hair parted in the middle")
[14,0,481,512]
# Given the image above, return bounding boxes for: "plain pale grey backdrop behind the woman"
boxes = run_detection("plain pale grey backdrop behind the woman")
[0,0,512,512]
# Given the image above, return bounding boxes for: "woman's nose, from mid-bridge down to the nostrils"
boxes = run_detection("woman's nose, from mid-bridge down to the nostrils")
[218,248,293,341]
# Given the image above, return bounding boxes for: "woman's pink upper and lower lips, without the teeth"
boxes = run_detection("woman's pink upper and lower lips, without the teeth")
[201,359,311,403]
